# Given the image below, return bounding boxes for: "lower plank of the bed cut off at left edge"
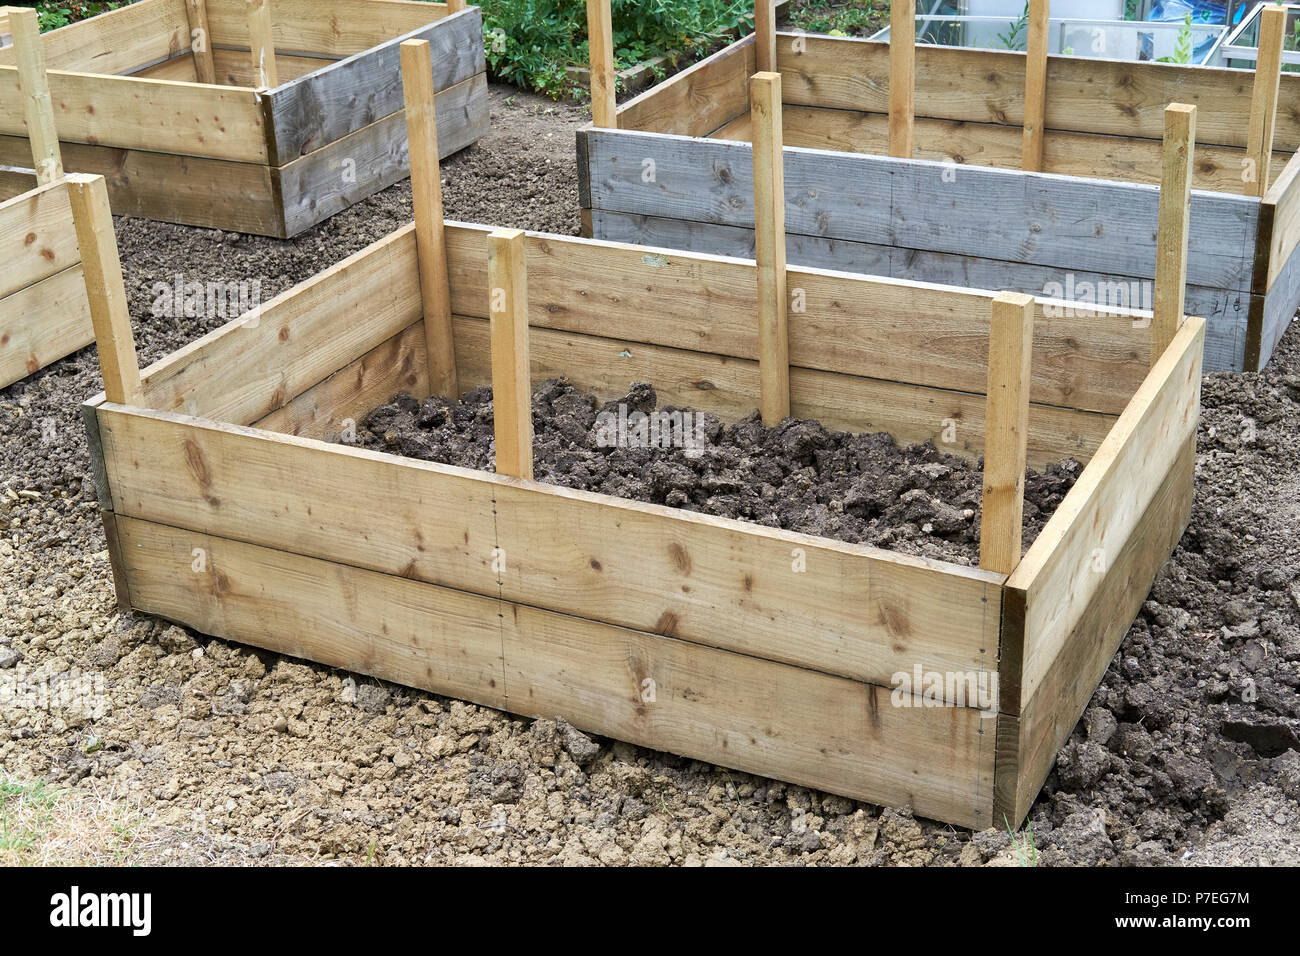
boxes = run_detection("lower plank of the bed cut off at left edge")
[0,265,95,389]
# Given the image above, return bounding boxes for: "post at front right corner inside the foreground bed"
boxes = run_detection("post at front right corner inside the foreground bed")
[979,293,1034,575]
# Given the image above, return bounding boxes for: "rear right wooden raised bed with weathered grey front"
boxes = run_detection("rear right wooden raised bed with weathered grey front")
[579,0,1300,371]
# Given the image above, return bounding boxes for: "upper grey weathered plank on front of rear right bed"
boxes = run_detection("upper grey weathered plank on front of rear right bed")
[585,130,1260,291]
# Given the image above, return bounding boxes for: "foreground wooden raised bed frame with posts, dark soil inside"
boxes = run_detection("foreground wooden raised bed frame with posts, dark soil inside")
[85,44,1205,827]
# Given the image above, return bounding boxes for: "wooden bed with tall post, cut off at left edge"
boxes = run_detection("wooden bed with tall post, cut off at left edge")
[0,8,113,389]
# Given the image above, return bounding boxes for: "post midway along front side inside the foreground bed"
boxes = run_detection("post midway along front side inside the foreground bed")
[488,229,533,479]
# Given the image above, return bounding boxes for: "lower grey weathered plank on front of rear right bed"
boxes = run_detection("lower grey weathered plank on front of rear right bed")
[592,209,1252,372]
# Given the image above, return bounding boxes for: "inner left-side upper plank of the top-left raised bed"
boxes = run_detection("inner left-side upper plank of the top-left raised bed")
[0,0,190,75]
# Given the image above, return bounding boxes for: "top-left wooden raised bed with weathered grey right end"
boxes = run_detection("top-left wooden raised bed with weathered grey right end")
[0,0,488,238]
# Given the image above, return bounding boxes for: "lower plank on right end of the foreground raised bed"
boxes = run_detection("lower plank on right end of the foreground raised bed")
[993,438,1196,829]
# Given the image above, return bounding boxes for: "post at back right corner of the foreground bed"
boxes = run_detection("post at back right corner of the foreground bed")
[1151,103,1196,365]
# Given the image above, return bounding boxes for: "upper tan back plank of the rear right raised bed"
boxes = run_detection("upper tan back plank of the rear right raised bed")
[777,34,1300,152]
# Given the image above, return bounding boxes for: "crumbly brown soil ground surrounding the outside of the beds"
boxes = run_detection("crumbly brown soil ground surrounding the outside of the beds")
[0,88,1300,865]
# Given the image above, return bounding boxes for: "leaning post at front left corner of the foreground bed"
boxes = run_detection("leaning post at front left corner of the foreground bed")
[68,173,143,405]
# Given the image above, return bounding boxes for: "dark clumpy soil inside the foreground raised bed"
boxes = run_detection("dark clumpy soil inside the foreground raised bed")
[356,380,1080,564]
